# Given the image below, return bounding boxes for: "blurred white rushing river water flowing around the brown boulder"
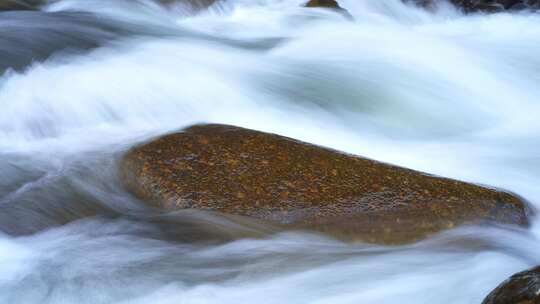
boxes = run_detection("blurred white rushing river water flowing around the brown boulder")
[0,0,540,304]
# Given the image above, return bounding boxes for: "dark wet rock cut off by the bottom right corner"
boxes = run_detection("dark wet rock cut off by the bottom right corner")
[482,267,540,304]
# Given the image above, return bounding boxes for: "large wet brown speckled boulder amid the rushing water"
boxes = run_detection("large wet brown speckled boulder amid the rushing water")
[121,124,528,244]
